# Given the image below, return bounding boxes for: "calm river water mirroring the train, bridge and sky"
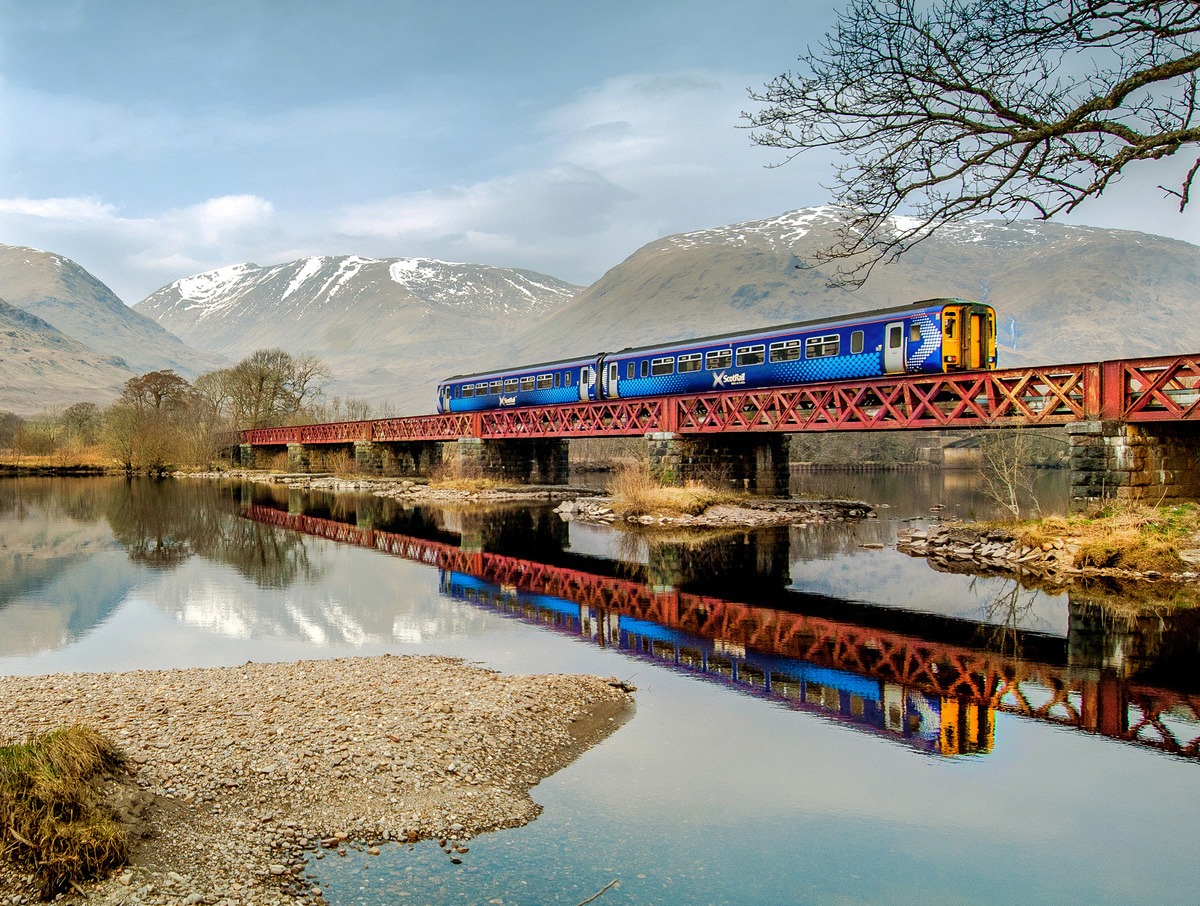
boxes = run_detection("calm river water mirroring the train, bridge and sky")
[0,473,1200,906]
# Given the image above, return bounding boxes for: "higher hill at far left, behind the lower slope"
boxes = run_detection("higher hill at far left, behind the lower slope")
[0,246,228,379]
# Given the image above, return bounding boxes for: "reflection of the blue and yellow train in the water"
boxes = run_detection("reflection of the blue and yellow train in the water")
[440,570,995,755]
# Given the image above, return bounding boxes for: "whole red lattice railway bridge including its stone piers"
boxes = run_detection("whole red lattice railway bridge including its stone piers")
[227,353,1200,505]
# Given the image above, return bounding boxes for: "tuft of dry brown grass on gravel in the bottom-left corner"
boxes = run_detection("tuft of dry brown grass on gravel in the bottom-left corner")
[0,726,130,899]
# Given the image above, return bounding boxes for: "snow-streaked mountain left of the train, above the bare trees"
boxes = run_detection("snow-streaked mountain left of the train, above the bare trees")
[134,256,581,413]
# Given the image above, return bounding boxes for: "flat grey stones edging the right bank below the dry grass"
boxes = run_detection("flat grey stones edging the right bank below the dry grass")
[896,524,1200,584]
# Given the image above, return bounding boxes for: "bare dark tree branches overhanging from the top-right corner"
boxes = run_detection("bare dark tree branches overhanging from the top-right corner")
[744,0,1200,286]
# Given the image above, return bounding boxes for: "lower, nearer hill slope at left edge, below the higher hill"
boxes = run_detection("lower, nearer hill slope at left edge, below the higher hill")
[0,300,133,415]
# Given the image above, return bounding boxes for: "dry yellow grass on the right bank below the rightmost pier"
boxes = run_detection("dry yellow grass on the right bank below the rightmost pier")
[974,503,1200,572]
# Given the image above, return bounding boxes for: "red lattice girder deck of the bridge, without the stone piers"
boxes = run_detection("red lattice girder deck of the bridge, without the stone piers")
[232,353,1200,446]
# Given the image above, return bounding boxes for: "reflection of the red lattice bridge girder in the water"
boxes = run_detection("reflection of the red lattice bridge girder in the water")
[244,505,1200,757]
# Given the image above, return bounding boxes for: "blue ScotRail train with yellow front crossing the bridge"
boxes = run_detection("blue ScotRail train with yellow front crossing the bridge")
[438,299,996,412]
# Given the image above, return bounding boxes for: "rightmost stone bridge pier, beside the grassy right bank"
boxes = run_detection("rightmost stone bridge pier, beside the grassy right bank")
[1067,420,1200,511]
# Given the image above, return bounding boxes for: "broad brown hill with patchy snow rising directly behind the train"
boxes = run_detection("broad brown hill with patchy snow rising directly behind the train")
[492,208,1200,370]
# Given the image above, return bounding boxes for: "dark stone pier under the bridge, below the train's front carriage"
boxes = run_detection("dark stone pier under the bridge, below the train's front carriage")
[646,433,791,497]
